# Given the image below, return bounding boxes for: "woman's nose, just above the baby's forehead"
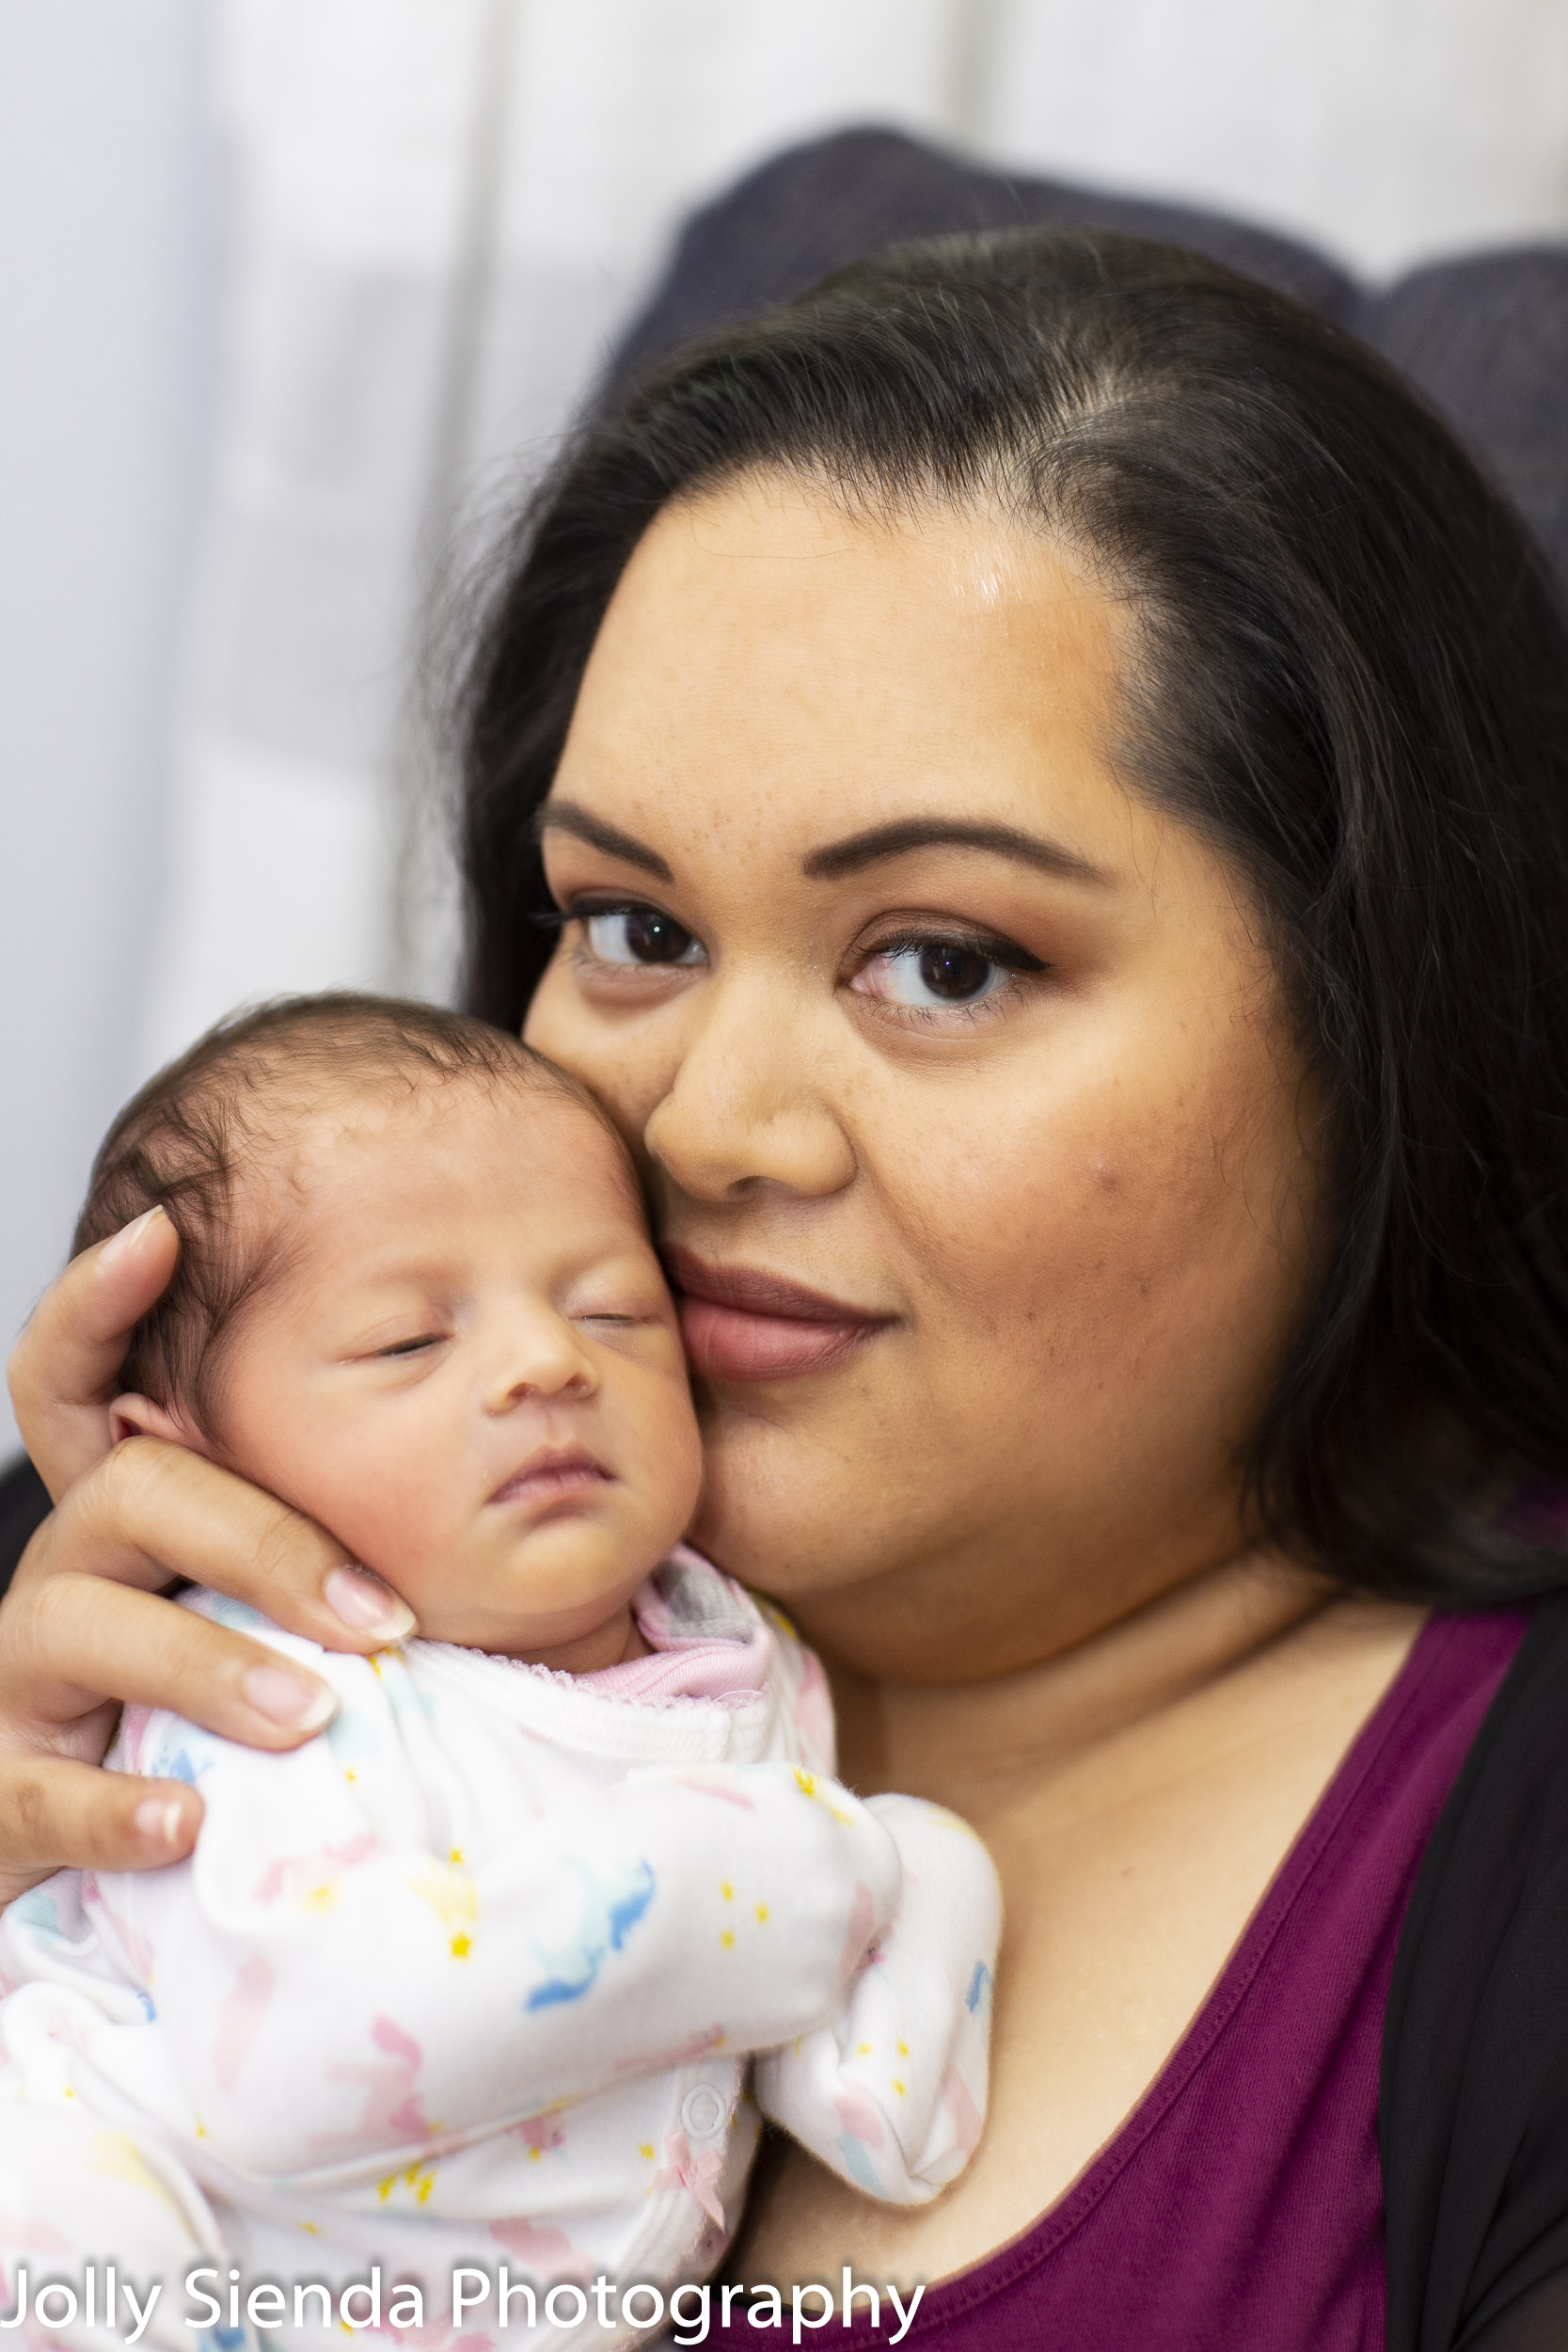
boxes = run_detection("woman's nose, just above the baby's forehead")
[644,983,856,1200]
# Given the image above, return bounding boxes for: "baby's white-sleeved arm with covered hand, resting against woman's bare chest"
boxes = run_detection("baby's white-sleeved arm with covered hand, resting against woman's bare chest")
[757,1797,1002,2204]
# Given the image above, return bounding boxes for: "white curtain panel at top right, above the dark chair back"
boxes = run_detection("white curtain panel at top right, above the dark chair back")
[983,0,1568,278]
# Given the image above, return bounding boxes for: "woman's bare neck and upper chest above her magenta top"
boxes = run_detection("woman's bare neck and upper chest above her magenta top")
[740,1552,1422,2284]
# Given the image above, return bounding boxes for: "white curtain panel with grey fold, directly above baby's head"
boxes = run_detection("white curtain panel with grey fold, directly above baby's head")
[141,0,991,1066]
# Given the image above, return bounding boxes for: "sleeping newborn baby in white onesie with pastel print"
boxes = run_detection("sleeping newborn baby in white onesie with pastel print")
[0,997,999,2352]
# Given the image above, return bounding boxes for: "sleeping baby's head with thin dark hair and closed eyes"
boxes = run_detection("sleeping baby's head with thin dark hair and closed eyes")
[75,995,701,1663]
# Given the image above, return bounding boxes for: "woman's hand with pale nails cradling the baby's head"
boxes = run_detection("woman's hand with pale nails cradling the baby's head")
[0,1209,414,1903]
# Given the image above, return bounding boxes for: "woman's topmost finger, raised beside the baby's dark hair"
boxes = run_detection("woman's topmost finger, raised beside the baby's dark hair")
[9,1209,179,1501]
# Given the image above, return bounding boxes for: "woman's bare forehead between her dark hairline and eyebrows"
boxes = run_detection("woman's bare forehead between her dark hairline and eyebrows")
[552,478,1129,864]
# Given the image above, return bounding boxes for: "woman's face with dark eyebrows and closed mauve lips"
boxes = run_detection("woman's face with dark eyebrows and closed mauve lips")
[527,478,1314,1679]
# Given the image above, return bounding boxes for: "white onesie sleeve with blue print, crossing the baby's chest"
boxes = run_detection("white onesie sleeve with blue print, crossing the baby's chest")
[96,1628,900,2183]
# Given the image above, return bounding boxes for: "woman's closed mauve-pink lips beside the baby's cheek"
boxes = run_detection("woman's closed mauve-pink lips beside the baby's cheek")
[663,1242,895,1381]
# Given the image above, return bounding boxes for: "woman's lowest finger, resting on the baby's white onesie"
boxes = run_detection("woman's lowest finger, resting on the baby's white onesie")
[0,1755,202,1905]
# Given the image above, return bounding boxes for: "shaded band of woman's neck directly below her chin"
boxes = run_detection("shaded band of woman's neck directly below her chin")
[828,1548,1340,1814]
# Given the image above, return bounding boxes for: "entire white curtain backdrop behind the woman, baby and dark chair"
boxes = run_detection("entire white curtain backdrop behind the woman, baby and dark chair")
[0,0,1568,1447]
